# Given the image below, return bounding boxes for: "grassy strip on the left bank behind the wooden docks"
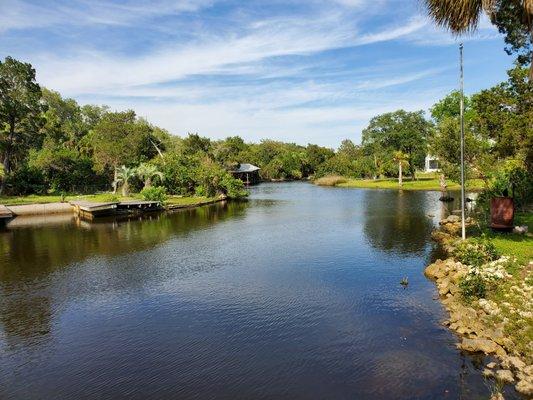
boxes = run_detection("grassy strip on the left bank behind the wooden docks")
[0,193,220,207]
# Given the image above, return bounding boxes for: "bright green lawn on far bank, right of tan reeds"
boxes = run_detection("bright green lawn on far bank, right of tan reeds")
[336,177,483,191]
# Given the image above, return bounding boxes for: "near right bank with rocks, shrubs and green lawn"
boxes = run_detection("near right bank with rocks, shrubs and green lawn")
[425,213,533,397]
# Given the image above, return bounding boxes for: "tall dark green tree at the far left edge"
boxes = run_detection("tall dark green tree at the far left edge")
[0,57,43,193]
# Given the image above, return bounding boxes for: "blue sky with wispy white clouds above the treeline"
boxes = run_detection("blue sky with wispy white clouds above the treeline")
[0,0,513,147]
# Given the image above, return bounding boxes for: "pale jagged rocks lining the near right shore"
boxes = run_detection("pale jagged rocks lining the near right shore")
[425,215,533,399]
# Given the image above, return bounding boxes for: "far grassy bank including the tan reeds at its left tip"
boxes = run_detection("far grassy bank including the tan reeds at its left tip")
[314,176,483,191]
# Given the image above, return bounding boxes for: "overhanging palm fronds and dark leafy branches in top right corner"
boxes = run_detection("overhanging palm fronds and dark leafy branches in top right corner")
[425,0,533,81]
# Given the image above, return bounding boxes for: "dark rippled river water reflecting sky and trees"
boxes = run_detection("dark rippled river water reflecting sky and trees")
[0,183,498,400]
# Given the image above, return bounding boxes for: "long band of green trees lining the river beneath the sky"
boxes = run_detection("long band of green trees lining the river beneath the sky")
[0,57,533,200]
